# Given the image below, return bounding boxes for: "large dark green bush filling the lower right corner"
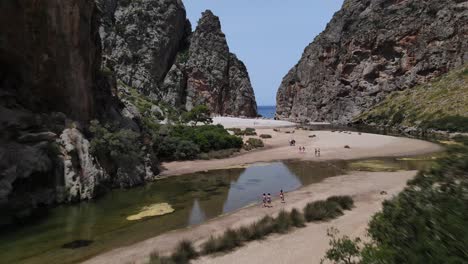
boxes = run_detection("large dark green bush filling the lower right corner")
[326,137,468,264]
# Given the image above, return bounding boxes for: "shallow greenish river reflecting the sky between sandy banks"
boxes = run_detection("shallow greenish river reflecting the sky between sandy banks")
[0,158,434,263]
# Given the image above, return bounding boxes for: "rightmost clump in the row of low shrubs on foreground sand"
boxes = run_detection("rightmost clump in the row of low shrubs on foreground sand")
[304,201,343,222]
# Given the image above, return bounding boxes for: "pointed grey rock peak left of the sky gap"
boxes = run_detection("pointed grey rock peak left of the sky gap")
[185,11,257,117]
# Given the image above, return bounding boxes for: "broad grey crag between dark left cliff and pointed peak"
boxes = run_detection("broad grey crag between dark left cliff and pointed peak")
[98,0,191,97]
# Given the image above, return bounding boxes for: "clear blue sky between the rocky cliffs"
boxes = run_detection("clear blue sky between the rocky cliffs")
[184,0,343,105]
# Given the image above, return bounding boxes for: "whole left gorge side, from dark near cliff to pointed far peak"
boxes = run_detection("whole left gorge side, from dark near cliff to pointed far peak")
[0,0,257,225]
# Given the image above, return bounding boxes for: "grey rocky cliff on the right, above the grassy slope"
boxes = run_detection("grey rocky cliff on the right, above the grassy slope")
[277,0,468,123]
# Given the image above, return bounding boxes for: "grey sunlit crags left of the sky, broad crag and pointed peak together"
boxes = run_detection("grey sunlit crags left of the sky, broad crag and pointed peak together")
[99,3,257,116]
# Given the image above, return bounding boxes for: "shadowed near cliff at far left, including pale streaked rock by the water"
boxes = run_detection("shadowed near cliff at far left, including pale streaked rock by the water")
[0,0,148,226]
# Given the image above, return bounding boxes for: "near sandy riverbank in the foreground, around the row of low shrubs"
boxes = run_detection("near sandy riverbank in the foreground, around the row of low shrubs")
[84,171,416,264]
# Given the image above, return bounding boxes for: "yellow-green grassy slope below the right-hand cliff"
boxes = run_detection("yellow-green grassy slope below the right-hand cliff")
[355,65,468,132]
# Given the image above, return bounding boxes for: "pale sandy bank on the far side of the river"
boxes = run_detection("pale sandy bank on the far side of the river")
[161,128,442,176]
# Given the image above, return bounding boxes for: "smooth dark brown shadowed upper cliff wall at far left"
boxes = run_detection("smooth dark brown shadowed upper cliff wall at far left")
[0,0,101,121]
